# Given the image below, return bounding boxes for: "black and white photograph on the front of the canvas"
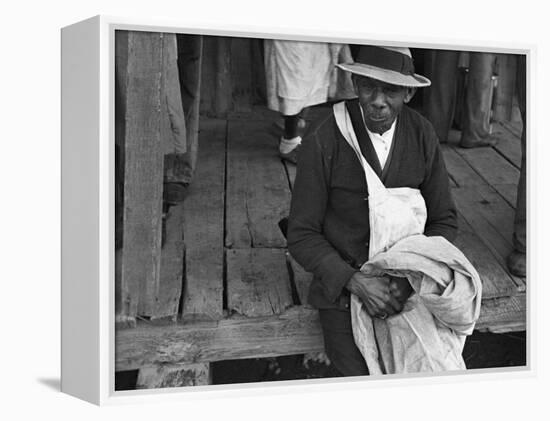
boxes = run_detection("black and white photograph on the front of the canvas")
[111,29,530,391]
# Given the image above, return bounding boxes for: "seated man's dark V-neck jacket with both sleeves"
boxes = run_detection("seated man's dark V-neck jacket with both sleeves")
[288,100,457,308]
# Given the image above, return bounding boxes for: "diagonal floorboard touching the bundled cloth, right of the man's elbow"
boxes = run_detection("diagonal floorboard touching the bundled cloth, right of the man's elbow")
[455,215,517,298]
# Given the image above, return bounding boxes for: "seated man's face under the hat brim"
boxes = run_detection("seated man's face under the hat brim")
[353,76,415,134]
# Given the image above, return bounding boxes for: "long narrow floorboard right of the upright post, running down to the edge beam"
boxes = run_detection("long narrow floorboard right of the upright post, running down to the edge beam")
[182,120,227,320]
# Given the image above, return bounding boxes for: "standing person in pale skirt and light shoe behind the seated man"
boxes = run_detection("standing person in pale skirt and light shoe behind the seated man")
[264,39,354,163]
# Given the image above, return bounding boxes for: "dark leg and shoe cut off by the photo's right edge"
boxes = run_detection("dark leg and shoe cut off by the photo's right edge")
[507,55,527,277]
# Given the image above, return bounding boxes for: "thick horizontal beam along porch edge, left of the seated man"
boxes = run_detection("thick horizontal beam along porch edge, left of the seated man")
[115,306,324,371]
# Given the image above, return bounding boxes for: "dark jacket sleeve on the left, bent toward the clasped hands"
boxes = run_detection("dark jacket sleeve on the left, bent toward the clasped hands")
[287,128,356,302]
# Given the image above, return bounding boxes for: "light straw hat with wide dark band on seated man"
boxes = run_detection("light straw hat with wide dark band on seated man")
[337,45,431,88]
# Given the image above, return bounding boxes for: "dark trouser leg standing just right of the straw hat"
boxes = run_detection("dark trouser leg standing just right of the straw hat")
[424,50,460,143]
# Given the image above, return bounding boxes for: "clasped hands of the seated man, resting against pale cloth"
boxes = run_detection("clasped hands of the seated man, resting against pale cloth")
[347,272,412,319]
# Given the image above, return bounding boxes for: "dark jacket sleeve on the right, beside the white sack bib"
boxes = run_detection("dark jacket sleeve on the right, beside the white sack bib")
[420,124,458,242]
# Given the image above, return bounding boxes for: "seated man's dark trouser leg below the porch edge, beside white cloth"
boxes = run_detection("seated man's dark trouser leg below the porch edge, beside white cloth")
[319,310,369,376]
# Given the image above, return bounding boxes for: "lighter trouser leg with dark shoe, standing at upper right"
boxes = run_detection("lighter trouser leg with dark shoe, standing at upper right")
[460,52,496,148]
